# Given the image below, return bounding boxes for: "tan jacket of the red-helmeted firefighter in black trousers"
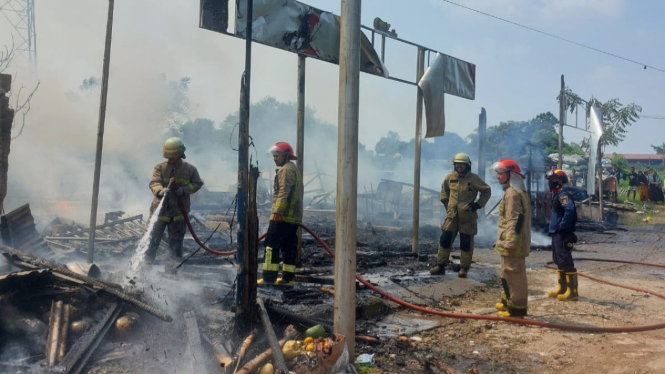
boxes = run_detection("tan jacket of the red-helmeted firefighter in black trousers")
[270,162,302,224]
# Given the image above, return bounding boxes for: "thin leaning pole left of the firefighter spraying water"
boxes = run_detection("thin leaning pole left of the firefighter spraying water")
[88,0,114,264]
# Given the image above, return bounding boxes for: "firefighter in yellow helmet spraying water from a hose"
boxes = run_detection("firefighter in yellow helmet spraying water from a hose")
[146,138,203,263]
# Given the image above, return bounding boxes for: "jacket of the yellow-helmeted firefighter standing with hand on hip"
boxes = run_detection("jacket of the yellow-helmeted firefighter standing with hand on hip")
[441,171,492,235]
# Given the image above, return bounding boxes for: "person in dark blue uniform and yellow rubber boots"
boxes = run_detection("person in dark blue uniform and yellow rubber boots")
[545,170,579,301]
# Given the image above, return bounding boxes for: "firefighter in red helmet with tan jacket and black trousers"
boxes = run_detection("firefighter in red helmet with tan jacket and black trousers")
[259,142,302,285]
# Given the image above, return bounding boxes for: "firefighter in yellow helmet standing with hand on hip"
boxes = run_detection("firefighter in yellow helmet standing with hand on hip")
[430,153,492,278]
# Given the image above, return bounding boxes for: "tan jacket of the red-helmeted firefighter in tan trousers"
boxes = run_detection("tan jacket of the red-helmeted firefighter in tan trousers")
[494,186,531,257]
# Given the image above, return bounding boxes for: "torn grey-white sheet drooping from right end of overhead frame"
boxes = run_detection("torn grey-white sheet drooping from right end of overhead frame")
[418,53,476,138]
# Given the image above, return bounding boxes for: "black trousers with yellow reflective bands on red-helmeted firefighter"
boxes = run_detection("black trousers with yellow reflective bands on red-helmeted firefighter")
[263,221,298,282]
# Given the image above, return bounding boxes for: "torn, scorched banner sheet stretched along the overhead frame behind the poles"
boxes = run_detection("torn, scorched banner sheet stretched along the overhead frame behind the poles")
[235,0,388,77]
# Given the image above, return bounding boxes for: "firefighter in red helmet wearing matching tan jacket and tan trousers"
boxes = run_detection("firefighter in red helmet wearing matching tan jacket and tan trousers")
[491,158,531,318]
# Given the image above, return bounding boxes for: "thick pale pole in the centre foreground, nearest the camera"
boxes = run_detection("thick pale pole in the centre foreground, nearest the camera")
[334,0,361,357]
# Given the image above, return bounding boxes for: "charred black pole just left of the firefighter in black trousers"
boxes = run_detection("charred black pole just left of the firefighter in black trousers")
[236,0,256,328]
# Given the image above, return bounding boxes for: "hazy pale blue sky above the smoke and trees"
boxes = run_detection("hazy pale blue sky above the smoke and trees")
[0,0,665,153]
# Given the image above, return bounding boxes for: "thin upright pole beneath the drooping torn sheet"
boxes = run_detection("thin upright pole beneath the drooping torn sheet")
[411,48,425,253]
